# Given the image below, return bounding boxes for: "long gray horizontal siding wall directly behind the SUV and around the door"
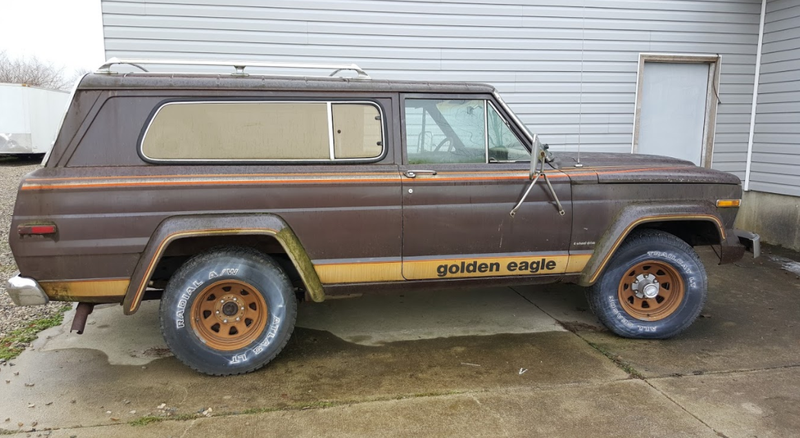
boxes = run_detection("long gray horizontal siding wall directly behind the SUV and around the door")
[102,0,760,177]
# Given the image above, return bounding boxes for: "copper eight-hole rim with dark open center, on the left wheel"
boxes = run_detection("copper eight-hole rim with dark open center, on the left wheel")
[191,280,267,351]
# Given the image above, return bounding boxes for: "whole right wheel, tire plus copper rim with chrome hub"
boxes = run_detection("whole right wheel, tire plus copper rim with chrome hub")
[586,230,708,339]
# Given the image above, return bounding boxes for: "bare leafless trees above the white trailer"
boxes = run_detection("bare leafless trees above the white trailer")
[0,51,73,90]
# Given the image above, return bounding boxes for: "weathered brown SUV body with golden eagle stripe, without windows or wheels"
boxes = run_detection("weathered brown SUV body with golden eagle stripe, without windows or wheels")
[10,75,743,313]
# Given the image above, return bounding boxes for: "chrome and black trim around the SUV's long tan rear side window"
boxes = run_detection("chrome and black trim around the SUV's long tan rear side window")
[137,99,389,164]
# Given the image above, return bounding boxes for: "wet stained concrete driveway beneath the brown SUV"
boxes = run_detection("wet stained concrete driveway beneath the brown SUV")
[0,248,800,437]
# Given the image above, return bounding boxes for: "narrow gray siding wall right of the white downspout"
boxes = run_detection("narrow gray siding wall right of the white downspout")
[750,0,800,196]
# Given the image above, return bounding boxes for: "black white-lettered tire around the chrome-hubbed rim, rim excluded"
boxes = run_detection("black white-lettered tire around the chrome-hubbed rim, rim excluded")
[588,230,708,339]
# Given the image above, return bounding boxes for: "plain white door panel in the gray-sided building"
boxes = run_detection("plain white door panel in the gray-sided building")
[636,62,709,166]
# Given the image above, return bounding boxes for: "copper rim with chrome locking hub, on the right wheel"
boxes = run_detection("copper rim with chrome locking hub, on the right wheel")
[617,260,686,321]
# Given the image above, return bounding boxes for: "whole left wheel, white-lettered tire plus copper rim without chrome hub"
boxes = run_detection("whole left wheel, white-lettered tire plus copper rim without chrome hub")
[159,247,297,376]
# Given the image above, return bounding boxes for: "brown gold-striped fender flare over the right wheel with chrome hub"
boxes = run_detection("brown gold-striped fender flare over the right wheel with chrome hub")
[578,205,728,286]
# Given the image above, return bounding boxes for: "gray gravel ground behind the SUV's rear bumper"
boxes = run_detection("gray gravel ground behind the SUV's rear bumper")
[0,158,69,338]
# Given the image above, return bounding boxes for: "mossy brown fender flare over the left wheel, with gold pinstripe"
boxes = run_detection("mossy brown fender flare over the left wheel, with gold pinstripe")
[122,214,325,315]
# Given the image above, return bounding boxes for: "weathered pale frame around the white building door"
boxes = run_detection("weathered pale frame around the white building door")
[631,53,722,168]
